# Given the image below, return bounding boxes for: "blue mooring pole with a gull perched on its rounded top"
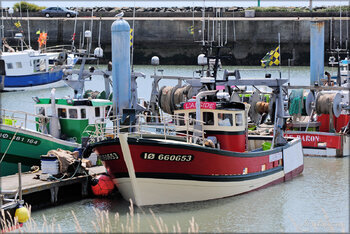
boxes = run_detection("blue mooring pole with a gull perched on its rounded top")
[111,19,131,115]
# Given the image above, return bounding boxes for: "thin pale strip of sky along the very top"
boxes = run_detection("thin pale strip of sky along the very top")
[0,0,350,7]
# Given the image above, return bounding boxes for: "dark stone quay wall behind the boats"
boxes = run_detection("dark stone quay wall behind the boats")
[4,17,350,66]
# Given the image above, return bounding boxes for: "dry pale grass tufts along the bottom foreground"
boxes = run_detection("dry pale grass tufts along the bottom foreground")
[3,200,347,233]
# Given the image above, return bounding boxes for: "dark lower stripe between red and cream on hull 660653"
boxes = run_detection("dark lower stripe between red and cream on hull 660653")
[113,166,283,182]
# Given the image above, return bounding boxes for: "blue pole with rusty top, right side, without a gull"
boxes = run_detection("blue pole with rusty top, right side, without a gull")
[310,21,324,85]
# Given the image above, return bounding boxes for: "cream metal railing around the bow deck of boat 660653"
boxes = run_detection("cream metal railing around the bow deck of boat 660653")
[83,114,206,145]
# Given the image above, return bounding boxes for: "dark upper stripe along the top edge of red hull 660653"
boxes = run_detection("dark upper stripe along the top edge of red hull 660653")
[91,138,286,158]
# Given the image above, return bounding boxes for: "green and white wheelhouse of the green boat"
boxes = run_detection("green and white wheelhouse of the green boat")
[35,98,113,143]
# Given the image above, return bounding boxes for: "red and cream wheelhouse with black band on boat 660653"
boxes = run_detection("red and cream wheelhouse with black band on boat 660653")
[175,102,249,152]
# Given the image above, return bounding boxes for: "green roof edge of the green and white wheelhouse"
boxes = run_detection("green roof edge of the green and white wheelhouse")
[36,98,113,106]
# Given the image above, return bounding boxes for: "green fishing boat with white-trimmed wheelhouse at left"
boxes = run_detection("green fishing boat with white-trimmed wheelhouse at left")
[0,46,112,176]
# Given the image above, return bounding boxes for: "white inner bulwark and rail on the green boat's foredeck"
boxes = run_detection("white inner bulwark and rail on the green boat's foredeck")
[0,109,46,128]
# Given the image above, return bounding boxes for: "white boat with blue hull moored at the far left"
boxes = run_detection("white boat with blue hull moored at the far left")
[0,50,65,91]
